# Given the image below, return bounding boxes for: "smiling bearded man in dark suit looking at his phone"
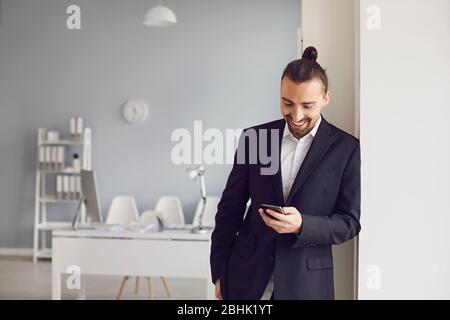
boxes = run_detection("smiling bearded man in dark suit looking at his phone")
[211,47,361,300]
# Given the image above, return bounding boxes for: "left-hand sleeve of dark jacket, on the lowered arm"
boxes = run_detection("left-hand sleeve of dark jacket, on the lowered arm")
[210,134,250,283]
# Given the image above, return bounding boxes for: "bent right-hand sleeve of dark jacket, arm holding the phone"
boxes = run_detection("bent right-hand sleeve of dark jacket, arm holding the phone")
[292,143,361,247]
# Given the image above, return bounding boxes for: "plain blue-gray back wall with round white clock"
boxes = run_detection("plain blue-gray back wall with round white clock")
[0,0,300,247]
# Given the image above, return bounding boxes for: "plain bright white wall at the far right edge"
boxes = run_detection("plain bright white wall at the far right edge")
[359,0,450,299]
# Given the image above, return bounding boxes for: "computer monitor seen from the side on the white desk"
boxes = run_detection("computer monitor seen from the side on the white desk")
[72,170,103,229]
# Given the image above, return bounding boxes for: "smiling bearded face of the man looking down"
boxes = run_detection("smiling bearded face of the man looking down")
[280,77,330,139]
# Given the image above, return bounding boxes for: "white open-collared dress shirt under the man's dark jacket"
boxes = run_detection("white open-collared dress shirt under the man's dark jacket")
[261,116,322,300]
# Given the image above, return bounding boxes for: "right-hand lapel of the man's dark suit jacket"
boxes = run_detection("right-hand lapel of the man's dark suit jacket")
[286,116,333,204]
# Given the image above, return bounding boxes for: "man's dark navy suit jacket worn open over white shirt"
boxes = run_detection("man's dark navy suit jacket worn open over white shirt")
[210,116,361,299]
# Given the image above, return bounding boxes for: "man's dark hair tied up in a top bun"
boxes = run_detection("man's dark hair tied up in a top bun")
[281,47,328,93]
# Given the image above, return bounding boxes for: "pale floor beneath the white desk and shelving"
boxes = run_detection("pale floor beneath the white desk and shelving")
[0,256,205,300]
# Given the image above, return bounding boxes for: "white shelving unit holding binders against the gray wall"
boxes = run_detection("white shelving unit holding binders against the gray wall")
[33,128,92,262]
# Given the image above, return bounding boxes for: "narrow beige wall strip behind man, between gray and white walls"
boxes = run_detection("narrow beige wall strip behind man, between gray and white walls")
[302,0,356,299]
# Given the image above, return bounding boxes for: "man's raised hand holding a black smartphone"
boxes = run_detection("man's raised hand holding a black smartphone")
[260,207,302,234]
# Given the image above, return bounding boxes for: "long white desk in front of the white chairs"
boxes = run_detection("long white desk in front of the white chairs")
[52,230,215,300]
